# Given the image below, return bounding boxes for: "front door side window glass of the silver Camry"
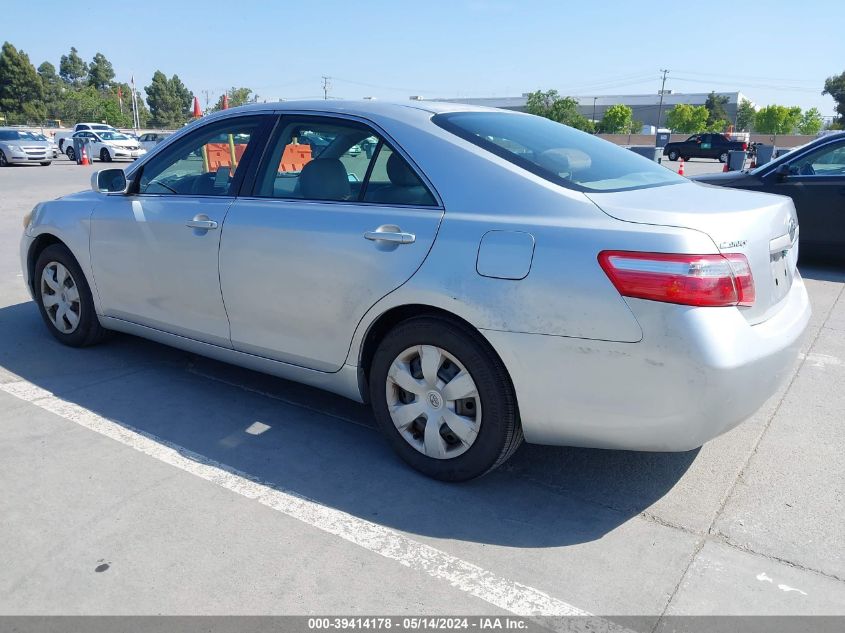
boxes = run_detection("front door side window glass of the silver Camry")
[138,116,263,196]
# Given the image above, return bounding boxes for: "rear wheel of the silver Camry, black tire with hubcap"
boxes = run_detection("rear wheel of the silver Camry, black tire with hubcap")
[369,317,522,481]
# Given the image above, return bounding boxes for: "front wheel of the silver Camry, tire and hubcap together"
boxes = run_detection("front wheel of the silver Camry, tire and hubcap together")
[33,244,107,347]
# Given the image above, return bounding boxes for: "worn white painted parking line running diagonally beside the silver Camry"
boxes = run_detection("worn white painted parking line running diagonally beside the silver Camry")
[0,380,608,630]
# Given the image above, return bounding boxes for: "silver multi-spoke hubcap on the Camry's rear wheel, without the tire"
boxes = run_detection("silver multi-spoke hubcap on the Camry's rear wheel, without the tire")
[386,345,481,459]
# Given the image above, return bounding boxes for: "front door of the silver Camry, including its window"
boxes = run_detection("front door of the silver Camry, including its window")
[91,115,272,347]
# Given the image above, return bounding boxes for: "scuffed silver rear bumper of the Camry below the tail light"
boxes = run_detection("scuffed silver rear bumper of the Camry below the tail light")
[483,276,810,451]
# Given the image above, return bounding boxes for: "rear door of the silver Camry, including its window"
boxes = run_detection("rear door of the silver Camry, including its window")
[220,114,443,371]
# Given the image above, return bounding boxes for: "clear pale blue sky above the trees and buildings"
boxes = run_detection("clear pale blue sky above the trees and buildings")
[6,0,845,115]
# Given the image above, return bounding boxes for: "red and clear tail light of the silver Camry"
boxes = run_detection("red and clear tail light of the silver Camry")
[599,251,755,306]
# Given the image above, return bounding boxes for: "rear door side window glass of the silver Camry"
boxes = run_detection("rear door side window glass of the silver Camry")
[255,117,436,206]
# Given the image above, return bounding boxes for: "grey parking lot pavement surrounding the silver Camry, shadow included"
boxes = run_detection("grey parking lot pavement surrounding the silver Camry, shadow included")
[0,160,845,627]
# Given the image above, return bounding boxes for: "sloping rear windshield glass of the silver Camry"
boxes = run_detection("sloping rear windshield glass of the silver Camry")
[433,112,686,192]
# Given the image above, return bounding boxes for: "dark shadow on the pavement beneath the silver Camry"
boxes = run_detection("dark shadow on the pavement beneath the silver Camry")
[0,302,698,548]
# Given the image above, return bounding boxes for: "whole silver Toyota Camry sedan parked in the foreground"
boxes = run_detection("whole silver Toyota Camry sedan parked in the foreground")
[21,101,810,481]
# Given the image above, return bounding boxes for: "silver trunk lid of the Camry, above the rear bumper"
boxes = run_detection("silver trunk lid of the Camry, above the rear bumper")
[587,182,798,324]
